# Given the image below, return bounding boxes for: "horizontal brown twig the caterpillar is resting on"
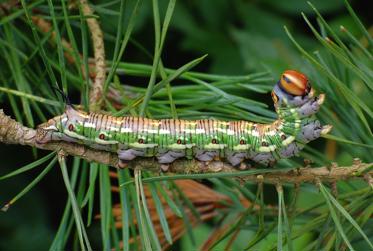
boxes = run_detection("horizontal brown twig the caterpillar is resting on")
[0,109,373,184]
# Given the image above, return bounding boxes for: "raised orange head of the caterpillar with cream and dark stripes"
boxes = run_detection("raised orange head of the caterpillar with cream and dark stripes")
[272,70,313,108]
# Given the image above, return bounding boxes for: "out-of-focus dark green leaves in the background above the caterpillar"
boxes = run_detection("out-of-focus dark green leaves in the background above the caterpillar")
[96,0,369,75]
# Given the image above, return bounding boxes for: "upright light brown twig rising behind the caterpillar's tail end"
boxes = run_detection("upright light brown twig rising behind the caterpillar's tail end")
[80,0,106,111]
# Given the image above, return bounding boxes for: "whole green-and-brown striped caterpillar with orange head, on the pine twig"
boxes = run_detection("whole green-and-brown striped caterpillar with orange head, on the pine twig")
[37,70,332,166]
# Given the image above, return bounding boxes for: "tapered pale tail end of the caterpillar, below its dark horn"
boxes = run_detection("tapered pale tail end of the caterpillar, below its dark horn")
[36,105,88,144]
